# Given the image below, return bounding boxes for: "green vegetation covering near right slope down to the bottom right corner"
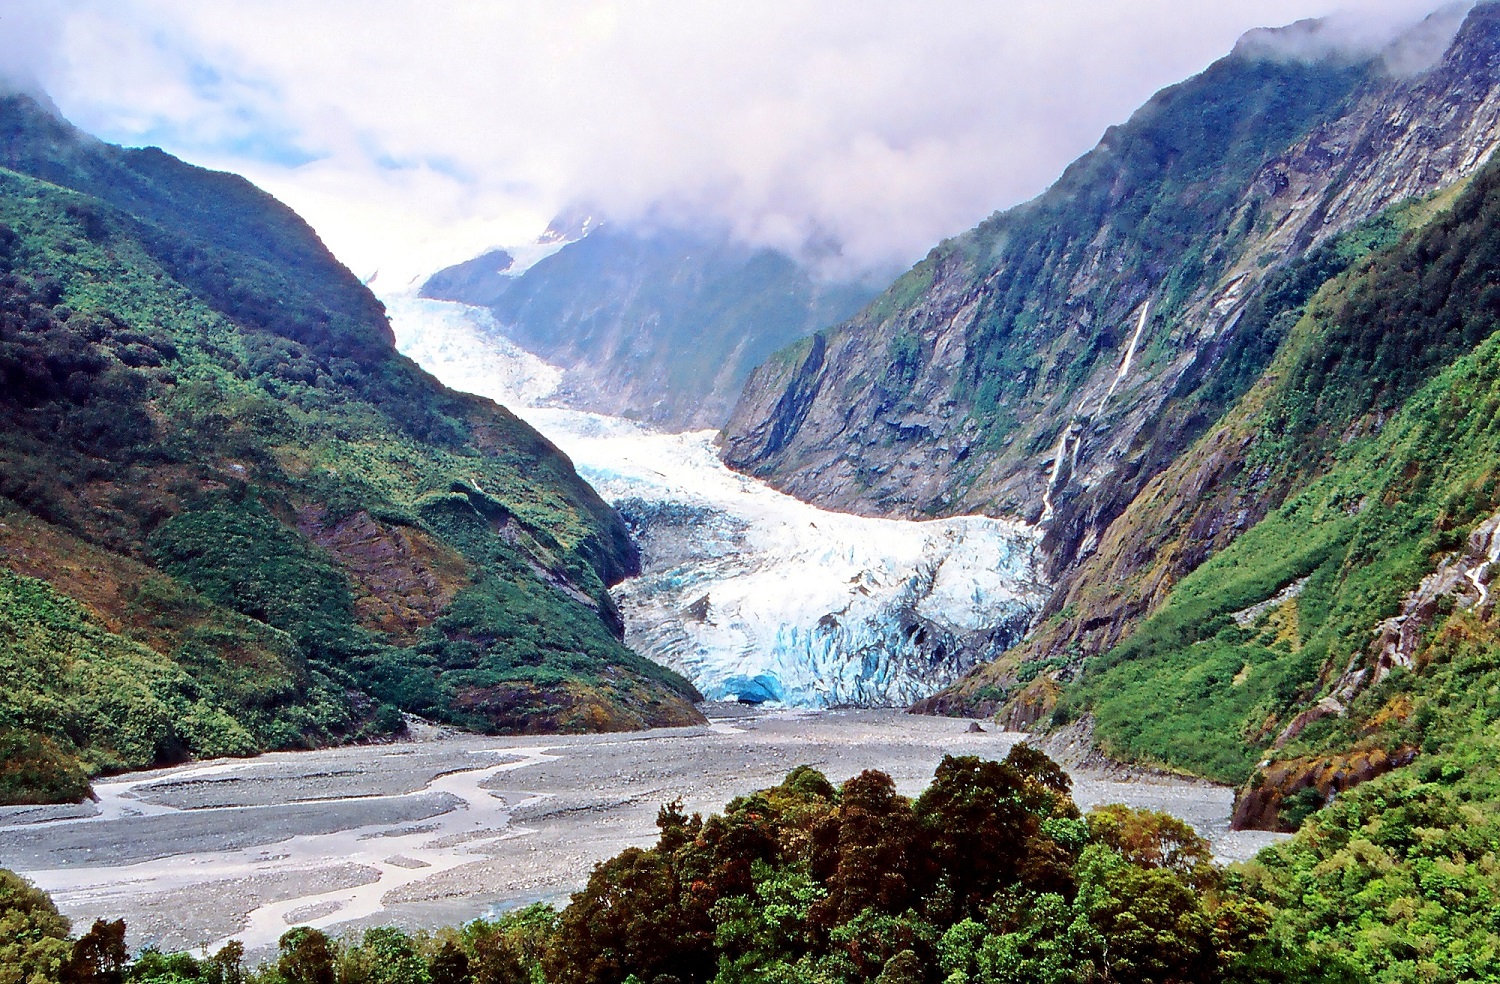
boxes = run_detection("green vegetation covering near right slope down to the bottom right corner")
[888,42,1500,983]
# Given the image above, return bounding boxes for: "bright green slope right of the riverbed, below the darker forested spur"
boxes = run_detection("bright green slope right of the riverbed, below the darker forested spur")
[1064,328,1500,783]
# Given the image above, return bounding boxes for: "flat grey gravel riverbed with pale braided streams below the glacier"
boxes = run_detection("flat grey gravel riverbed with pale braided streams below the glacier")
[0,705,1274,956]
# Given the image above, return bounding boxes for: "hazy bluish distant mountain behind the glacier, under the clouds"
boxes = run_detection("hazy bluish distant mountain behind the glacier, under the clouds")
[422,224,876,429]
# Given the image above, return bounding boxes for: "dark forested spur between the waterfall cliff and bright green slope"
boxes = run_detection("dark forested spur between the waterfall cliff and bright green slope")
[935,78,1494,723]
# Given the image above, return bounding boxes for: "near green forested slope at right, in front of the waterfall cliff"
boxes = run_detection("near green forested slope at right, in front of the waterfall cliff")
[944,132,1500,827]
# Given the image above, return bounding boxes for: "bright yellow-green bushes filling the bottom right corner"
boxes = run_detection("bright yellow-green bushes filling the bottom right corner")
[1239,729,1500,984]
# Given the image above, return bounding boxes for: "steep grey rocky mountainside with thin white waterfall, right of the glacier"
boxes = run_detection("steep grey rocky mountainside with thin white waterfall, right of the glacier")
[723,6,1500,588]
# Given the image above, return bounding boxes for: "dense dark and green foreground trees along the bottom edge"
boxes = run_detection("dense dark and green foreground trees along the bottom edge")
[0,746,1500,984]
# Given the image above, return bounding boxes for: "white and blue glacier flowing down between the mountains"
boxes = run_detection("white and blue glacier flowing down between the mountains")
[384,296,1049,708]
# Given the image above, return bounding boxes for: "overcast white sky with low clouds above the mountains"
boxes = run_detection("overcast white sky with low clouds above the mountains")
[0,0,1476,290]
